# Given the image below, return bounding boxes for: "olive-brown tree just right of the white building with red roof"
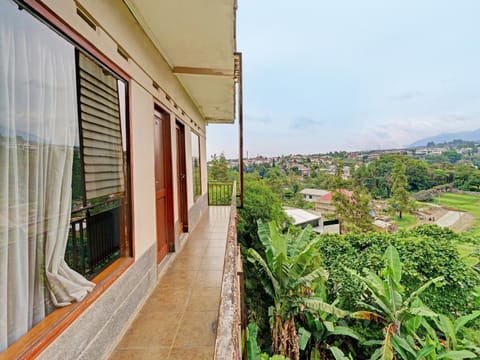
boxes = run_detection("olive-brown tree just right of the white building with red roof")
[333,188,374,232]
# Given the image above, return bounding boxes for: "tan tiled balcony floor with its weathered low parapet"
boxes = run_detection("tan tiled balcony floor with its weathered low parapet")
[111,186,240,359]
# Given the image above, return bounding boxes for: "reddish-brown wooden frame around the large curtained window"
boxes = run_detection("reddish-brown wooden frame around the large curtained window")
[0,0,135,360]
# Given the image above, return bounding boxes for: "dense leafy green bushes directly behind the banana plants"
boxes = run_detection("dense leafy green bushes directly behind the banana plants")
[318,225,479,315]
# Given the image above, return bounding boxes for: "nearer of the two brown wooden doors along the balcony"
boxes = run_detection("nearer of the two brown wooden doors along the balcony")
[154,110,173,262]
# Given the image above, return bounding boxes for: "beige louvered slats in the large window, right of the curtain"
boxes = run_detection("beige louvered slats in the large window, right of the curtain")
[78,53,125,200]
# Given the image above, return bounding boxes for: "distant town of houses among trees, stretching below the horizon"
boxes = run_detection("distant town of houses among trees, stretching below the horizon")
[209,140,480,233]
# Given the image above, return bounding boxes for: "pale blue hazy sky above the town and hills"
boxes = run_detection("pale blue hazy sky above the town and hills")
[207,0,480,158]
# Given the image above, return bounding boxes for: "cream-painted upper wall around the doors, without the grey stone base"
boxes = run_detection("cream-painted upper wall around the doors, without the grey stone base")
[39,0,206,258]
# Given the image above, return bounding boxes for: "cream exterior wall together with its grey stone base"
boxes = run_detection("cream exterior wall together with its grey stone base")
[8,0,208,359]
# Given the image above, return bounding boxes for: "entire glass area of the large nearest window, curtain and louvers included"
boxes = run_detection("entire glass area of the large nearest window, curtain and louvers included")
[0,0,128,352]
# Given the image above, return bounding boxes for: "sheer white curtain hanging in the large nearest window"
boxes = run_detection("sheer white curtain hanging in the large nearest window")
[0,0,94,352]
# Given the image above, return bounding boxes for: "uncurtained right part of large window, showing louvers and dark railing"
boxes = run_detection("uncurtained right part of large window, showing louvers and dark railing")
[65,50,127,277]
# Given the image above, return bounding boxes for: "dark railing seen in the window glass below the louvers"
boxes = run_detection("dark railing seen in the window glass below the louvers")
[65,199,121,278]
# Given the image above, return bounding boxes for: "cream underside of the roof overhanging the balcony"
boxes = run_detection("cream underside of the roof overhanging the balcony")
[124,0,236,123]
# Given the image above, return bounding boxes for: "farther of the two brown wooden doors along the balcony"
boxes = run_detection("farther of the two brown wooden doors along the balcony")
[176,121,188,234]
